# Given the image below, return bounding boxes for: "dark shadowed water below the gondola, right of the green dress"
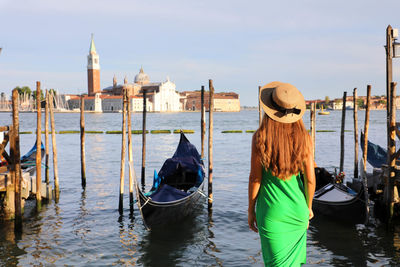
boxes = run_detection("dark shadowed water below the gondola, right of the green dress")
[308,215,400,266]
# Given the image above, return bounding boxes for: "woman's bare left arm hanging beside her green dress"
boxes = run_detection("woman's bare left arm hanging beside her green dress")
[247,135,262,233]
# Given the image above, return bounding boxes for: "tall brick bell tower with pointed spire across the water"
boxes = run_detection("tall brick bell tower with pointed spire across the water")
[87,34,100,96]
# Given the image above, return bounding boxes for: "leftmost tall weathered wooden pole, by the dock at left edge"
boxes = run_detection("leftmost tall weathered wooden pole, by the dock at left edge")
[10,89,22,227]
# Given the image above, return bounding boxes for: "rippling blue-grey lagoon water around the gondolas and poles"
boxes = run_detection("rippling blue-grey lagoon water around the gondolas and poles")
[0,111,400,266]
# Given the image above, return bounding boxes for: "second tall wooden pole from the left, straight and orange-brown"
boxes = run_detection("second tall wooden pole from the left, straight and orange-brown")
[36,82,42,209]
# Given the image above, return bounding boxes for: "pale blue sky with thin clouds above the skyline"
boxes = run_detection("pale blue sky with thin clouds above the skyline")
[0,0,400,106]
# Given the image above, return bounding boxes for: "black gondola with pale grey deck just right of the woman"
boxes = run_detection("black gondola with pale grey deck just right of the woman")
[313,169,368,224]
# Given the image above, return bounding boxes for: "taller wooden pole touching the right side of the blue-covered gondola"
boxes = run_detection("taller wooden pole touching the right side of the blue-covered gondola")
[208,79,214,209]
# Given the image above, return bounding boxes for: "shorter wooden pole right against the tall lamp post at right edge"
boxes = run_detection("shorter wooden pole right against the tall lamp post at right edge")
[385,82,397,222]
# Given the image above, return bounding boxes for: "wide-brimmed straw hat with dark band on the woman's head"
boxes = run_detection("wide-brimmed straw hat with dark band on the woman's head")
[260,82,306,123]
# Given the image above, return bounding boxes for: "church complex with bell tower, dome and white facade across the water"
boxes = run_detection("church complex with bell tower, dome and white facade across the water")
[81,34,240,112]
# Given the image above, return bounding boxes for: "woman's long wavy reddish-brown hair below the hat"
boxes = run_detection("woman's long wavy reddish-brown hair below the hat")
[254,114,311,180]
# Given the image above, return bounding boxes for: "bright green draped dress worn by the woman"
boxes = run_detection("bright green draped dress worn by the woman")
[256,169,309,266]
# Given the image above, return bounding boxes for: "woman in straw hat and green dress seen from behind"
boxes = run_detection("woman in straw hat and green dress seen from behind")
[248,82,315,266]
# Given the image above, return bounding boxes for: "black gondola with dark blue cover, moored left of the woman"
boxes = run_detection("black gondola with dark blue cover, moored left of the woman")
[135,133,205,229]
